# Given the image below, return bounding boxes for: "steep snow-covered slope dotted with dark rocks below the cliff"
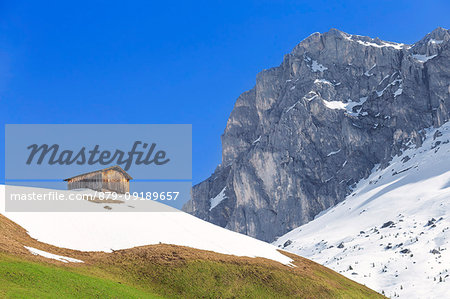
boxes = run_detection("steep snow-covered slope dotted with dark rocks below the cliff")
[274,123,450,298]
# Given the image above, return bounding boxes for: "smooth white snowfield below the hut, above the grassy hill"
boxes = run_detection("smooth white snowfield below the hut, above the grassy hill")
[0,186,291,264]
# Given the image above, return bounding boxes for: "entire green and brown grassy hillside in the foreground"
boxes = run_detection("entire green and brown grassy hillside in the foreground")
[0,215,383,298]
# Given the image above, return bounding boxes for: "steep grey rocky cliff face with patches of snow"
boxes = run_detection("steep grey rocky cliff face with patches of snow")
[184,28,450,241]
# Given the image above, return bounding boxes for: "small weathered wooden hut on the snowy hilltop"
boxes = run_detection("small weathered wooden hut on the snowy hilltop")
[64,165,133,194]
